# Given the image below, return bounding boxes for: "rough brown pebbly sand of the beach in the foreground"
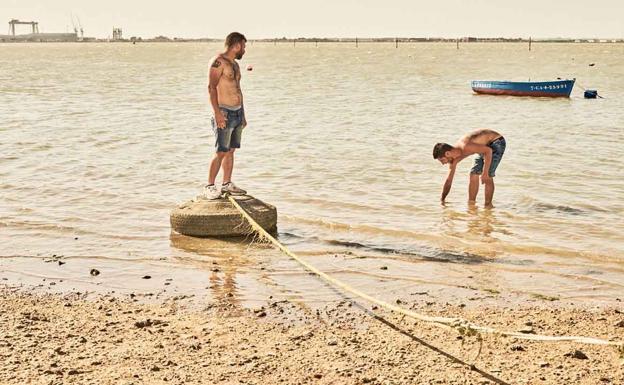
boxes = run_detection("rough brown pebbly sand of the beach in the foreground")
[0,278,624,384]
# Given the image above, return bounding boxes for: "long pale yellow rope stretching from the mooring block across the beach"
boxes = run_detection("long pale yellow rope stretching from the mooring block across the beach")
[228,195,624,352]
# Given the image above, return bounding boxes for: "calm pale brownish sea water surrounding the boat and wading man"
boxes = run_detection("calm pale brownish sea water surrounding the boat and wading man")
[0,43,624,300]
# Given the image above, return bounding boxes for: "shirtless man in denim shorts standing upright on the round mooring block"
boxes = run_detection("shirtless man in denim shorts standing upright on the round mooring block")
[202,32,247,199]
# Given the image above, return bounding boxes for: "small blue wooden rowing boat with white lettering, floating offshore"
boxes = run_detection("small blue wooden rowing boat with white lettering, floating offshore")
[472,79,576,98]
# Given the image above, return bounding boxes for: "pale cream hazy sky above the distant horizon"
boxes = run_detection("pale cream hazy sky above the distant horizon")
[0,0,624,39]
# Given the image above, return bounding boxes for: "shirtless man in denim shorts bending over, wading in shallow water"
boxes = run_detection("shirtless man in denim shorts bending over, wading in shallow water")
[433,129,506,207]
